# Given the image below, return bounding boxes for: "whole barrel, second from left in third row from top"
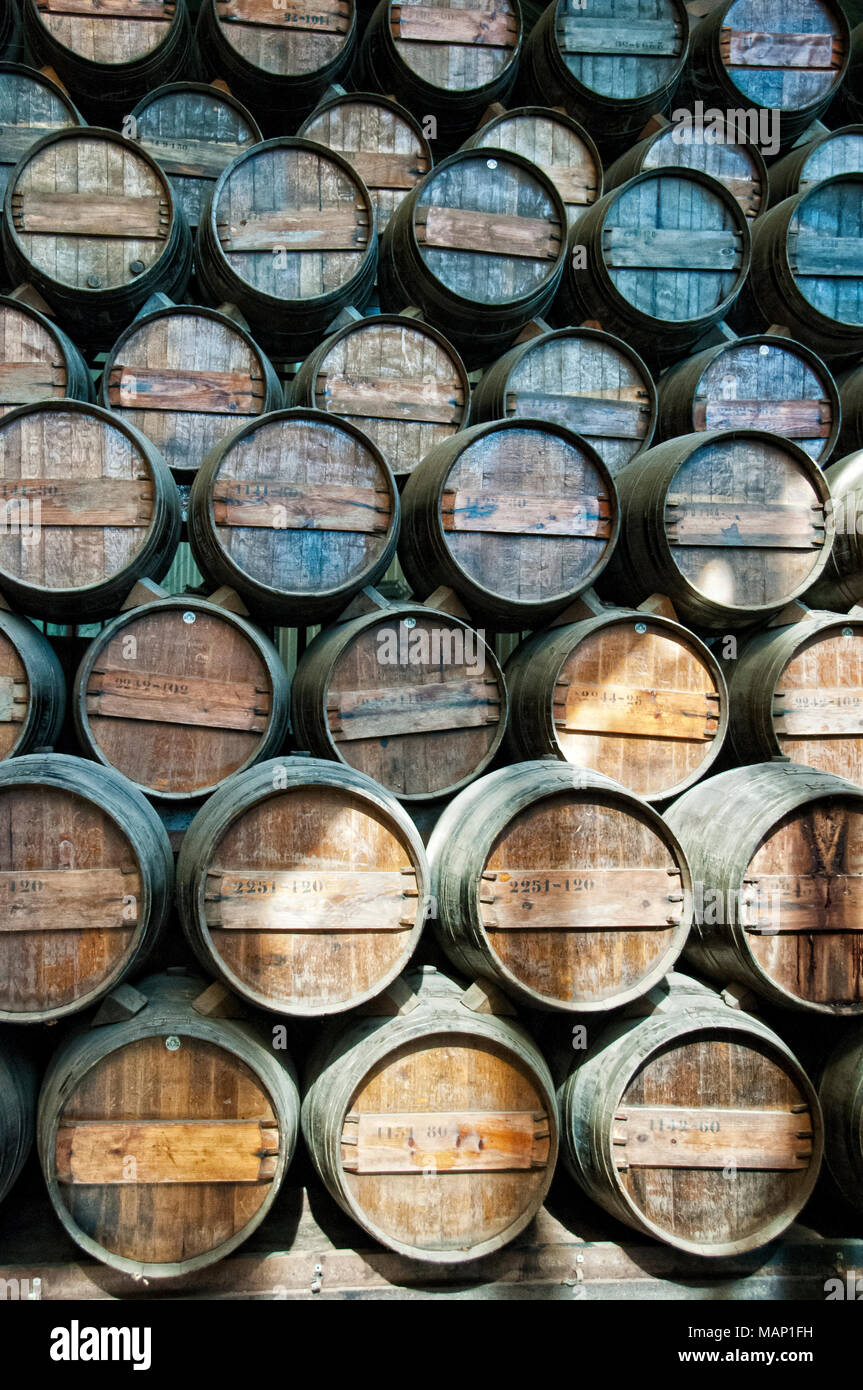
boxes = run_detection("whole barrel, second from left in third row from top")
[196,138,380,360]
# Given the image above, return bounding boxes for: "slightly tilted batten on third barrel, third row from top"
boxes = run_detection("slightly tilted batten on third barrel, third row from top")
[414,204,561,260]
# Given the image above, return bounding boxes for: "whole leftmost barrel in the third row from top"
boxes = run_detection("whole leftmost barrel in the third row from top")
[3,126,192,348]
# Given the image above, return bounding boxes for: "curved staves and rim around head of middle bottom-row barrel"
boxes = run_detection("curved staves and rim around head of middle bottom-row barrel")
[302,966,557,1265]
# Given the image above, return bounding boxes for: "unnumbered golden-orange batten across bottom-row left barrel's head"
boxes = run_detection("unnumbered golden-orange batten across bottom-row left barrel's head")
[56,1119,279,1187]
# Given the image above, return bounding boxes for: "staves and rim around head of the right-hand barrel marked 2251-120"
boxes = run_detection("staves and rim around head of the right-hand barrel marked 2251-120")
[427,758,692,1016]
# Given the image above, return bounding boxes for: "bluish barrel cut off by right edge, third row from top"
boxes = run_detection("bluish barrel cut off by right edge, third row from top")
[731,174,863,363]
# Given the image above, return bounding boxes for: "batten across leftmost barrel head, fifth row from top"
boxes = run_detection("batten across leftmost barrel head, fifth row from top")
[0,478,154,527]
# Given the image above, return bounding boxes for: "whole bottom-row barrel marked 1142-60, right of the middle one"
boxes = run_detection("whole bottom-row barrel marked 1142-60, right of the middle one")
[557,974,824,1257]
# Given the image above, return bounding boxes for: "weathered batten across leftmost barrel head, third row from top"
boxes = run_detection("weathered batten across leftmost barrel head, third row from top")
[11,192,171,240]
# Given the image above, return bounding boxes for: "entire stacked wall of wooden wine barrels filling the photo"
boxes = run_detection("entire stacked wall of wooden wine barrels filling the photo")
[0,0,863,1290]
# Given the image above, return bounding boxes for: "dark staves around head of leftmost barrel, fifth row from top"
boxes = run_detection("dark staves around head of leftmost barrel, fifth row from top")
[0,399,181,623]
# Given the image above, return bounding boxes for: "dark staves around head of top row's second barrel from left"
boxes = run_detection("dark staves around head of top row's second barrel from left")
[195,0,359,138]
